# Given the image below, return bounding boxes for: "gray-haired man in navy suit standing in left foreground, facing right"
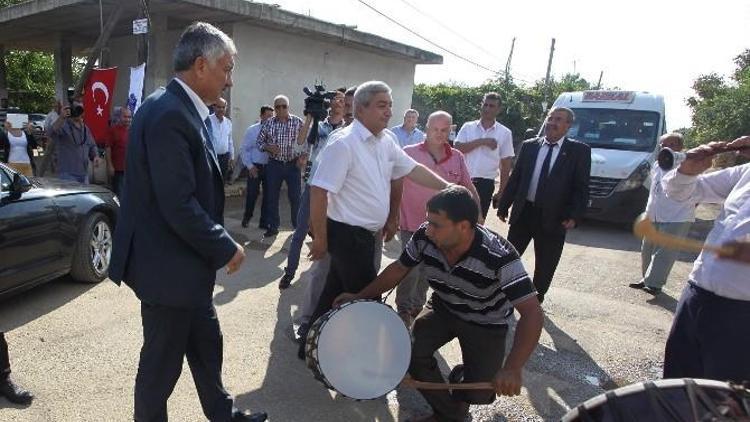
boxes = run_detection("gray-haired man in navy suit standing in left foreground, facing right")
[110,22,266,422]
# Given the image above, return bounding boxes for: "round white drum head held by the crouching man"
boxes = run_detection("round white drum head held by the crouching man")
[317,301,411,400]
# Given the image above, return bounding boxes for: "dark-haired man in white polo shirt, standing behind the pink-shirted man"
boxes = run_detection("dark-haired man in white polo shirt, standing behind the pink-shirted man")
[453,92,514,218]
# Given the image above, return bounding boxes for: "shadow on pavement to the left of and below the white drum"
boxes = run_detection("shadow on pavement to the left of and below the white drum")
[236,278,395,422]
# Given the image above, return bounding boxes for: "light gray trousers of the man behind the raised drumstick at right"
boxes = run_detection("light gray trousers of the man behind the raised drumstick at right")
[641,221,693,289]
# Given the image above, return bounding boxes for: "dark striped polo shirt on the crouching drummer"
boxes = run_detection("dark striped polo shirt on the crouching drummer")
[399,223,536,326]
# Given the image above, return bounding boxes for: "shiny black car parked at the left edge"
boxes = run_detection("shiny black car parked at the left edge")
[0,164,119,297]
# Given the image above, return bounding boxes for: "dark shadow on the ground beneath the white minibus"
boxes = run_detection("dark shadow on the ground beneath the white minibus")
[565,220,641,252]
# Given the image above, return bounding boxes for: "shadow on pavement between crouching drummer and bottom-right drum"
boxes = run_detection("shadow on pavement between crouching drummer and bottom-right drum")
[525,315,618,420]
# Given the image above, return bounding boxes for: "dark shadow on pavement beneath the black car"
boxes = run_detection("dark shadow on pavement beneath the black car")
[0,276,97,332]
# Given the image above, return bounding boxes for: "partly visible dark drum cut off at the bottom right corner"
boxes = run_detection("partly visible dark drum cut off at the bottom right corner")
[561,378,750,422]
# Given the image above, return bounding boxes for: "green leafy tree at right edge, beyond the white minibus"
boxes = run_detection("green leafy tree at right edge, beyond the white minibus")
[687,49,750,146]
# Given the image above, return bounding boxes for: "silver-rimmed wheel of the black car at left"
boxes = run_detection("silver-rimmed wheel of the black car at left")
[70,212,112,283]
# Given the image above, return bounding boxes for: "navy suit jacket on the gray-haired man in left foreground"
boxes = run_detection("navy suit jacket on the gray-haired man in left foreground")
[109,80,237,308]
